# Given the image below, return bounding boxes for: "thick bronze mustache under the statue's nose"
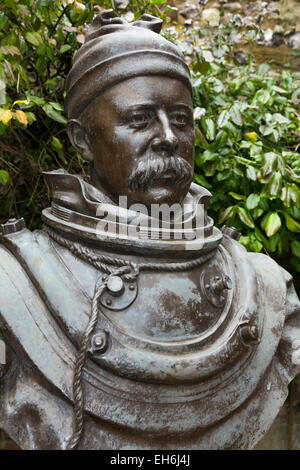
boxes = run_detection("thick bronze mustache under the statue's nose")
[127,154,194,192]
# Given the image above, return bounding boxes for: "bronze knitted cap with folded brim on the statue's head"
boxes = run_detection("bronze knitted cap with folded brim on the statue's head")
[65,10,192,119]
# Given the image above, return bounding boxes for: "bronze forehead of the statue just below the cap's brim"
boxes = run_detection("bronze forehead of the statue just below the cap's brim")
[92,75,192,111]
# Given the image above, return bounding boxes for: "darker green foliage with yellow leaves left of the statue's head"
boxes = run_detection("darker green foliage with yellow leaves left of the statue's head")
[0,0,166,228]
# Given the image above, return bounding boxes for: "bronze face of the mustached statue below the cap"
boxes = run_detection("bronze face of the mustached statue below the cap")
[83,76,194,206]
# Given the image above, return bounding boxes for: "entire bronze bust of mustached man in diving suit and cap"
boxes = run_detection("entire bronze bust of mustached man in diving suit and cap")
[0,11,300,449]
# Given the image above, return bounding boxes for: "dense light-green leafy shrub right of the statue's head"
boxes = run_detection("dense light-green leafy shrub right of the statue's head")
[194,52,300,272]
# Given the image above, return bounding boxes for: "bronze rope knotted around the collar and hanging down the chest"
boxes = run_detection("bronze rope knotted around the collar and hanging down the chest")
[44,226,215,450]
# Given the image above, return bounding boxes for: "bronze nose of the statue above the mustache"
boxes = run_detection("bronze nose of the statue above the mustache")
[151,110,178,154]
